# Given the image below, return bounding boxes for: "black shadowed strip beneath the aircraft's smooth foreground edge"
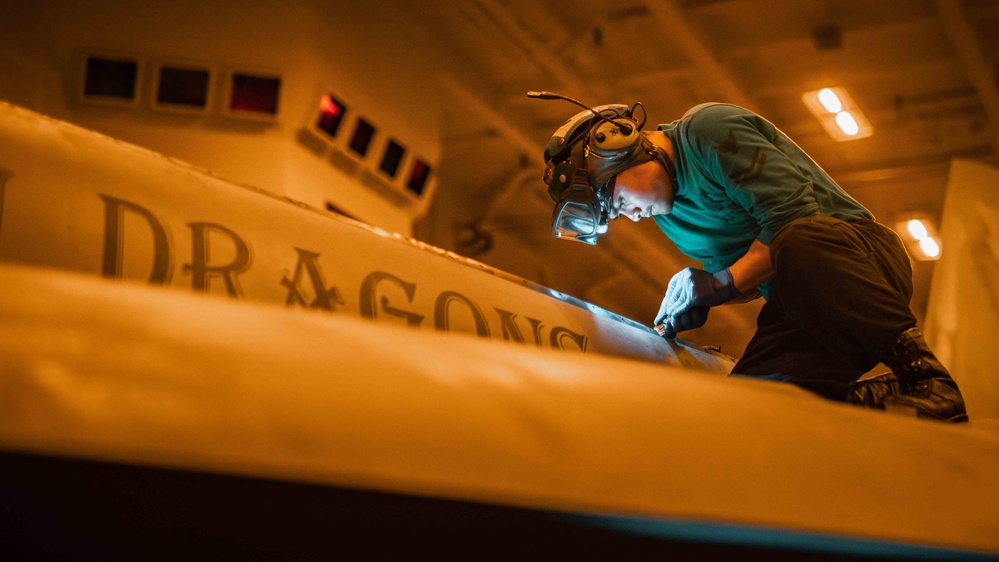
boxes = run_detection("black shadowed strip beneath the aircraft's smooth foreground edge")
[0,453,984,561]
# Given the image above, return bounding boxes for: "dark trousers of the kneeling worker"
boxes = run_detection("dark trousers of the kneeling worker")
[732,216,916,400]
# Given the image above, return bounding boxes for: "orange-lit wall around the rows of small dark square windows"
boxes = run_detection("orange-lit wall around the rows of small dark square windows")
[0,0,442,236]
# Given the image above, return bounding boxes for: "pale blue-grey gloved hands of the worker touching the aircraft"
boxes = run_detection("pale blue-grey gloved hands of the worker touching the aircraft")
[655,267,739,339]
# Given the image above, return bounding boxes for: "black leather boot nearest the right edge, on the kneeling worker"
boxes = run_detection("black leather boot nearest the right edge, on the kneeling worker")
[883,328,968,422]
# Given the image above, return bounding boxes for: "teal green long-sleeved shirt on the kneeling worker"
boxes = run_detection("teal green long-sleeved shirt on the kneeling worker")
[655,103,874,296]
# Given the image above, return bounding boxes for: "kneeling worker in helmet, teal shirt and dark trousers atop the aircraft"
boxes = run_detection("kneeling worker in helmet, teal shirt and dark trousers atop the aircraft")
[540,92,968,422]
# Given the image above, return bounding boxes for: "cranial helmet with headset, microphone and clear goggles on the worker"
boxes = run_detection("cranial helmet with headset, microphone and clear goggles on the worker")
[540,92,655,245]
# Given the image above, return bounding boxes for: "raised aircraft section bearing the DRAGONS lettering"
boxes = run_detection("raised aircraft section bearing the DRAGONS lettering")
[0,102,733,373]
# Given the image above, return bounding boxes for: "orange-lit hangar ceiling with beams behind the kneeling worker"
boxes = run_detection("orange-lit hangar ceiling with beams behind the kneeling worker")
[408,0,999,355]
